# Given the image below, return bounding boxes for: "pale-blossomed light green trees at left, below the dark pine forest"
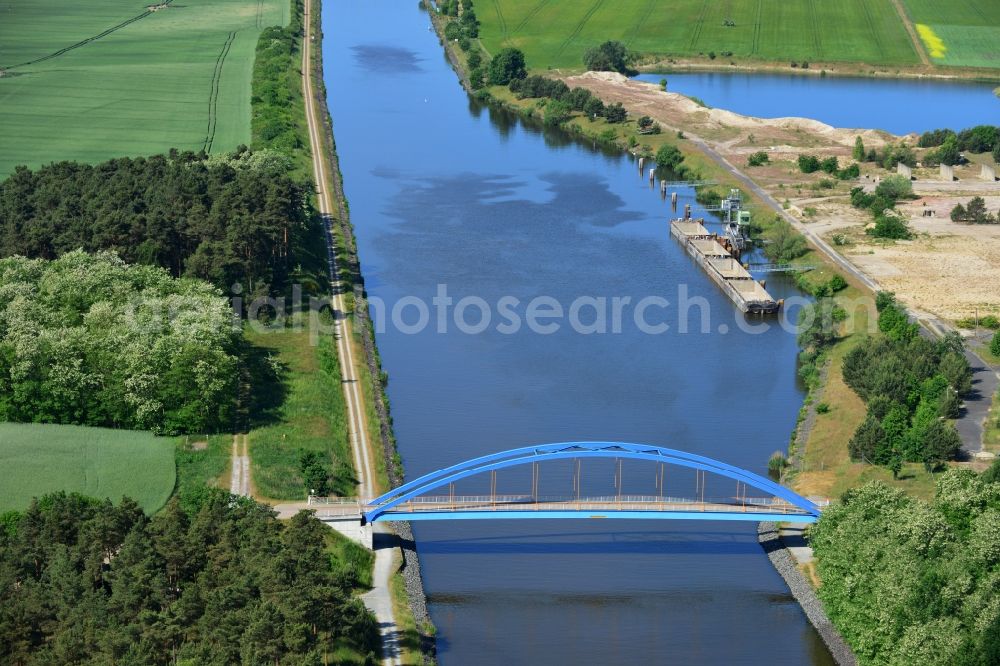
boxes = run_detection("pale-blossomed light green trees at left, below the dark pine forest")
[0,250,239,433]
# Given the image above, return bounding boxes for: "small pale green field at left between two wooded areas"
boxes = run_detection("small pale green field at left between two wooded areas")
[0,423,175,513]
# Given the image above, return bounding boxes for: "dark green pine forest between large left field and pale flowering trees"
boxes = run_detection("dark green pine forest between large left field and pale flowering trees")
[0,148,317,295]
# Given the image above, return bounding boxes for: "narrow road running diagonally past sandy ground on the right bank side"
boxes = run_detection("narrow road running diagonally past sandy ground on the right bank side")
[690,136,998,456]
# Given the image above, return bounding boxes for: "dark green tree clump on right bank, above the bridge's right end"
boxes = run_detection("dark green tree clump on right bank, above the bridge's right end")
[843,292,972,474]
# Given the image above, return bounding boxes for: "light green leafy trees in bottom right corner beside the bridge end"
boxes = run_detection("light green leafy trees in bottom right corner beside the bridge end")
[810,464,1000,666]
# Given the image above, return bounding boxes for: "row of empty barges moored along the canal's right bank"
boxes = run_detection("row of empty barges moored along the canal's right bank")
[670,219,781,314]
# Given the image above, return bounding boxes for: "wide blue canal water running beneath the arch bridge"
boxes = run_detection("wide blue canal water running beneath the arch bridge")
[323,0,831,665]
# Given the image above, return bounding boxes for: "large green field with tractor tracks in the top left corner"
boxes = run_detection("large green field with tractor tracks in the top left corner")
[0,0,290,177]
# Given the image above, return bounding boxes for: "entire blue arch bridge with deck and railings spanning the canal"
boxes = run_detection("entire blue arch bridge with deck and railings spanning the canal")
[309,442,825,524]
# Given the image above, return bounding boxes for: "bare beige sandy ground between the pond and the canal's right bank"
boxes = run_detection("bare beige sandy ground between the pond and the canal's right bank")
[564,72,1000,320]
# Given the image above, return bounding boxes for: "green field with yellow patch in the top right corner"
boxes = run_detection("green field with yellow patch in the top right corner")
[904,0,1000,67]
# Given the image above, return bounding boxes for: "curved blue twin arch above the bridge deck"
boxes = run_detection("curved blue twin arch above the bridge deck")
[364,442,819,522]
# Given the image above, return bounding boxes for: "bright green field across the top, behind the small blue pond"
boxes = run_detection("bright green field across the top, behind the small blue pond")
[476,0,920,69]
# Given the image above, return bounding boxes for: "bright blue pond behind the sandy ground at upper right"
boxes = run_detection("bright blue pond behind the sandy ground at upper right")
[637,72,1000,134]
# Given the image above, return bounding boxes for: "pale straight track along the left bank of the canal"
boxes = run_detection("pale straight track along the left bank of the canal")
[302,0,400,665]
